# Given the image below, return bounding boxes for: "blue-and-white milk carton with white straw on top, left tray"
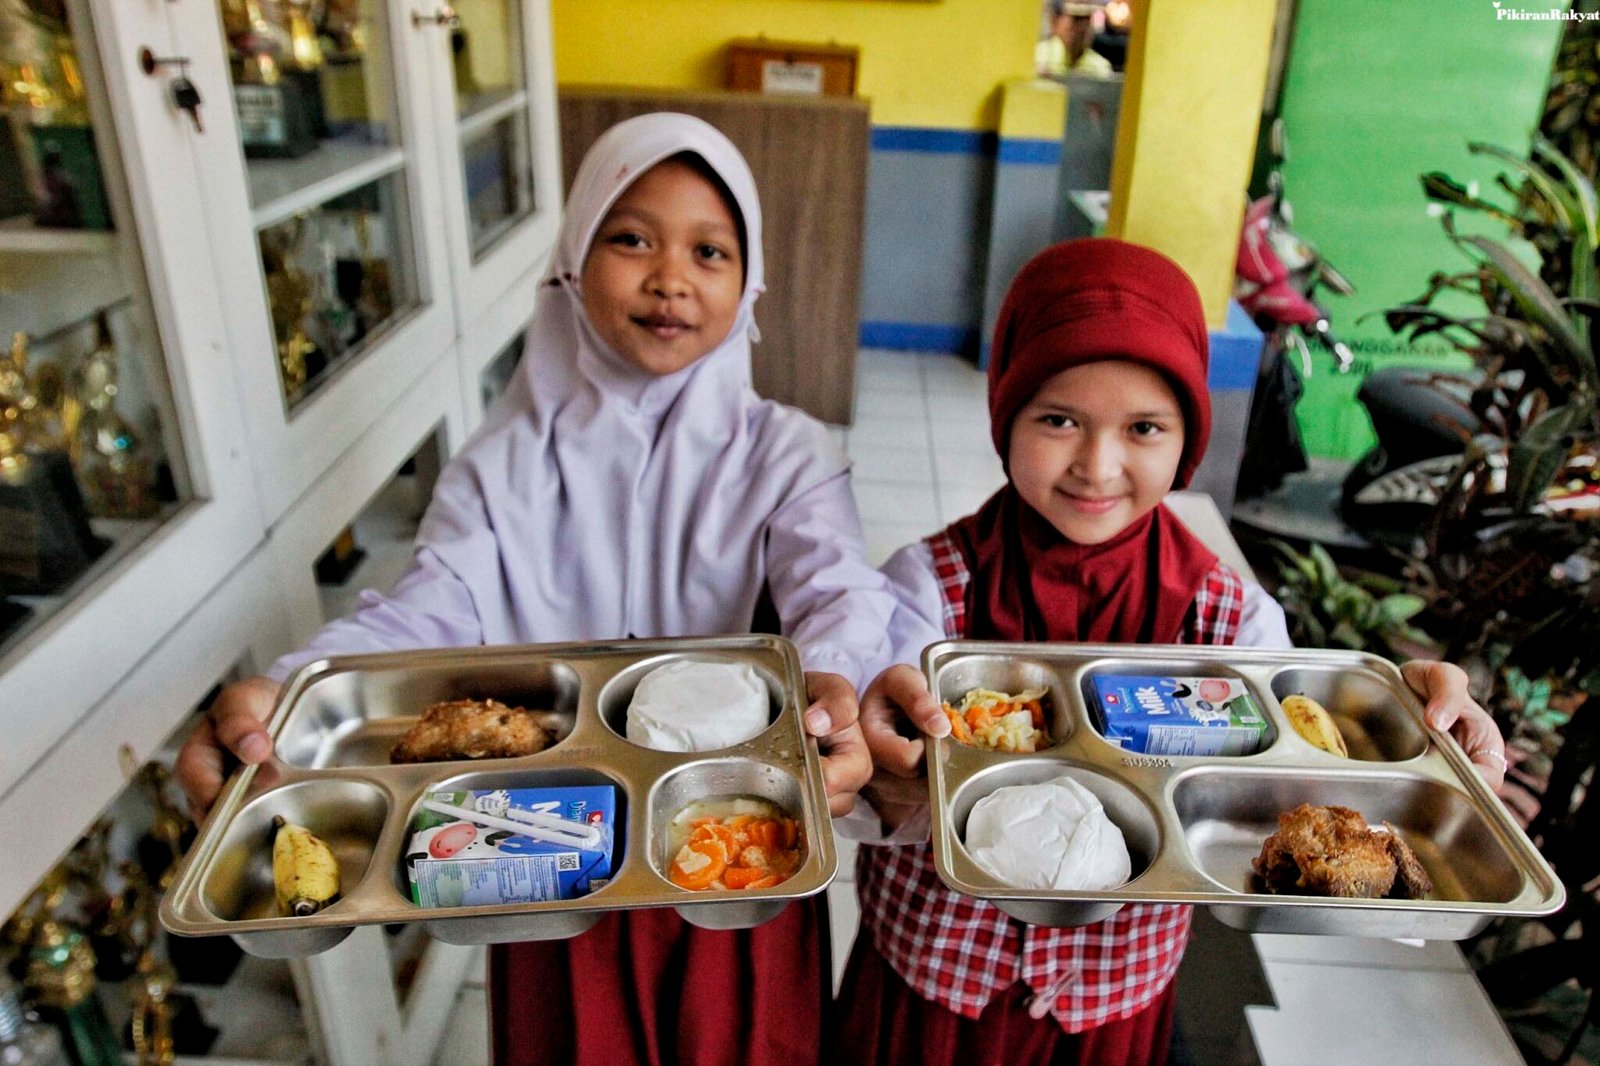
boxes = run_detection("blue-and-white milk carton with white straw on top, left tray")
[405,784,616,908]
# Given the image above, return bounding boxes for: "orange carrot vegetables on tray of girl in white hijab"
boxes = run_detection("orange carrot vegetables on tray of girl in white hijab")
[667,797,802,890]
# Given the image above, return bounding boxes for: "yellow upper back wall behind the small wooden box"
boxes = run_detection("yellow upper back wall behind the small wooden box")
[550,0,1040,130]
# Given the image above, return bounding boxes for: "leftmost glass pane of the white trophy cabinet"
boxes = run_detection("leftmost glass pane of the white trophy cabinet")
[0,0,192,655]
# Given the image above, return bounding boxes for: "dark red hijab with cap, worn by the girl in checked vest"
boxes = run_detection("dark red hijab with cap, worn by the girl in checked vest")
[950,238,1216,643]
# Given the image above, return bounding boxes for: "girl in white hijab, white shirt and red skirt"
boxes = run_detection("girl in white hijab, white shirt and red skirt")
[179,114,893,1063]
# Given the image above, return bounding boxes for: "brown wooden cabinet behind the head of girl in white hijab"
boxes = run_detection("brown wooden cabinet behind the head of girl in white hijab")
[560,86,869,424]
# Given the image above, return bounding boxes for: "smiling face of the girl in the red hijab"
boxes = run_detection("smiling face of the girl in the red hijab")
[1008,360,1184,544]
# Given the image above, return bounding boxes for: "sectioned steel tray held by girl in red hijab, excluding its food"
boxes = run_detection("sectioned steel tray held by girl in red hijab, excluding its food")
[923,640,1565,940]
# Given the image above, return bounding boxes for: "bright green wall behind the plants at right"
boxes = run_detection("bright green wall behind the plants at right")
[1282,0,1562,458]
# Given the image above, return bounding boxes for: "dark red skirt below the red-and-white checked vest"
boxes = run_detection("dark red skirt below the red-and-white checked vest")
[830,930,1178,1066]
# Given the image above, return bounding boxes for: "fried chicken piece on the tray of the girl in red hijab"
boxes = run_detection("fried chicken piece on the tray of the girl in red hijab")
[1251,804,1426,900]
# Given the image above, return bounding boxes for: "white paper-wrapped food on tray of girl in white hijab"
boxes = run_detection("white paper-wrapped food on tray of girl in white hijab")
[627,659,770,751]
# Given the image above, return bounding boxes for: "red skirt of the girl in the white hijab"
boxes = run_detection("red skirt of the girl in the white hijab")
[490,895,830,1066]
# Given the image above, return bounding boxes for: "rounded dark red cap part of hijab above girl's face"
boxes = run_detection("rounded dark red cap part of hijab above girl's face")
[989,237,1211,488]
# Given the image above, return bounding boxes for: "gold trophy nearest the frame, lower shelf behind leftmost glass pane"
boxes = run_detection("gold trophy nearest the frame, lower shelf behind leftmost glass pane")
[64,311,158,519]
